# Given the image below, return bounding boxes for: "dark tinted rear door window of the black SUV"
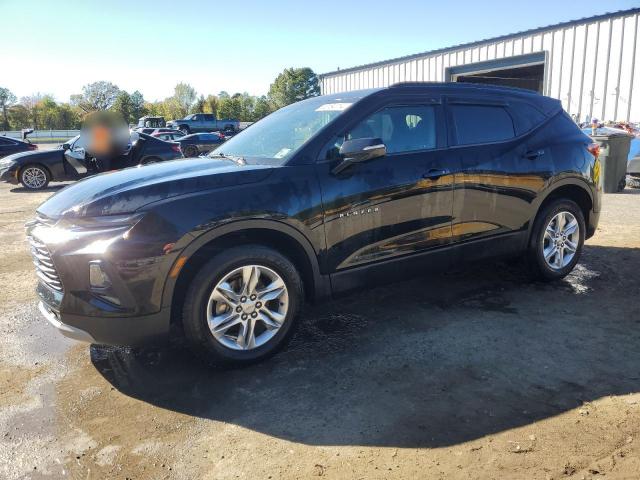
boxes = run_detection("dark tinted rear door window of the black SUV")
[449,105,515,145]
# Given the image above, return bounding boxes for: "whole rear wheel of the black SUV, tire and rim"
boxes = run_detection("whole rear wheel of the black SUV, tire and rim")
[527,199,586,281]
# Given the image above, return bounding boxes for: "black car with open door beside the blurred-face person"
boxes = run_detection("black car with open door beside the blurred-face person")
[0,133,182,190]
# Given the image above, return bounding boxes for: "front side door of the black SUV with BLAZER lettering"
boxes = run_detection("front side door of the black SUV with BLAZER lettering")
[317,101,457,272]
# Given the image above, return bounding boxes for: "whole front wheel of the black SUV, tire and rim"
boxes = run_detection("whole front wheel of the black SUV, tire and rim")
[182,245,304,366]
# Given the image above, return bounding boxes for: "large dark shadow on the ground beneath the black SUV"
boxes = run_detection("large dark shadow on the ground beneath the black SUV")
[91,246,640,447]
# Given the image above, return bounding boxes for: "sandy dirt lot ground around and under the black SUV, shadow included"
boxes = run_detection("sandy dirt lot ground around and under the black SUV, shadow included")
[0,181,640,479]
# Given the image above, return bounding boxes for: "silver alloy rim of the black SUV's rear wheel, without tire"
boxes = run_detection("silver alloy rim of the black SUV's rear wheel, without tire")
[542,211,580,270]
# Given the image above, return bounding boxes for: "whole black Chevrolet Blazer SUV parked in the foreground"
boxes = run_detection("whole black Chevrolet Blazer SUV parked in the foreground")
[28,83,601,364]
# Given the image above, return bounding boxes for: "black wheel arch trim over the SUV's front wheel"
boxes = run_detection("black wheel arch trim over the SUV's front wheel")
[163,220,330,323]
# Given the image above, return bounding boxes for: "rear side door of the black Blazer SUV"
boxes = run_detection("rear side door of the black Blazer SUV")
[447,100,552,242]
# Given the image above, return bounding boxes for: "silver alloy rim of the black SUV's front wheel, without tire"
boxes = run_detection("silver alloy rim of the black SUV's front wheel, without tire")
[207,265,289,350]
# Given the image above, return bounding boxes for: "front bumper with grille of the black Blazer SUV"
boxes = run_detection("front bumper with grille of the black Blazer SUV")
[27,214,178,346]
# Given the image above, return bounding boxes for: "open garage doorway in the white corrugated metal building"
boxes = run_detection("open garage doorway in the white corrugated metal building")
[447,52,546,93]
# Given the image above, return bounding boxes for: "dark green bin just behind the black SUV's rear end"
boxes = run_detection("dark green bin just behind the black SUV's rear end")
[591,128,631,193]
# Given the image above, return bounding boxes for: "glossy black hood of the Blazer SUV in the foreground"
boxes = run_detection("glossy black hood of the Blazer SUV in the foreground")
[37,157,274,218]
